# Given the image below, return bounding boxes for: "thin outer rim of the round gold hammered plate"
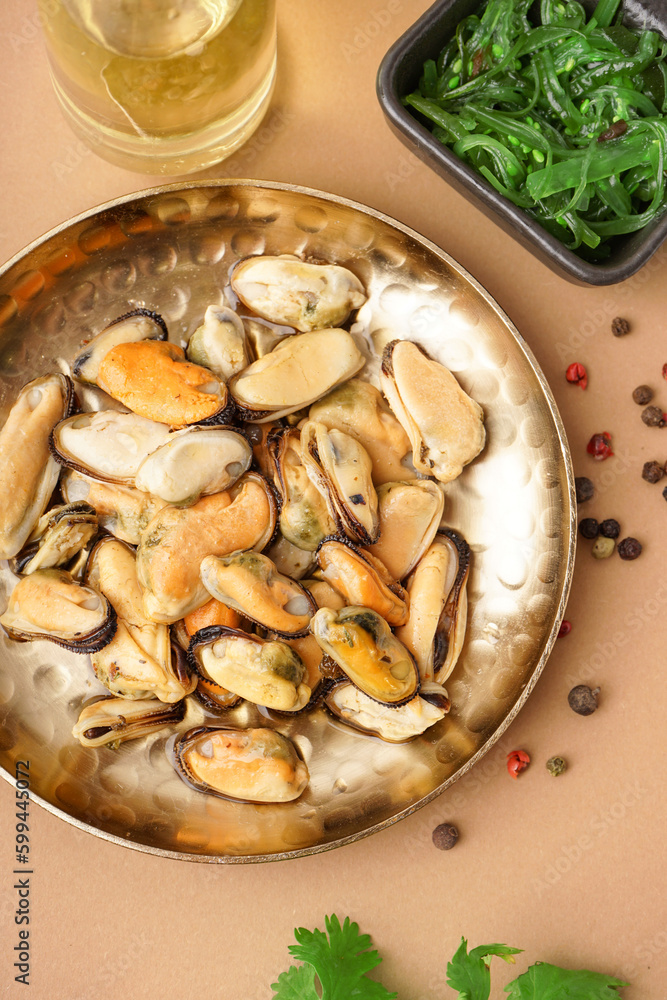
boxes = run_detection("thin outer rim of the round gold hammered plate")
[0,178,577,864]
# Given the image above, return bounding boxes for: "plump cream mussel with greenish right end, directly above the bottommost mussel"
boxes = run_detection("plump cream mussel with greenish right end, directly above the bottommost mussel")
[188,625,311,712]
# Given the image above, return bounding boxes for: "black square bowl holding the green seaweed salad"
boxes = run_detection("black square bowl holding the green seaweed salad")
[377,0,667,285]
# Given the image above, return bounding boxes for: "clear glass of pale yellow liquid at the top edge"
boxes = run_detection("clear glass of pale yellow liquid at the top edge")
[39,0,276,175]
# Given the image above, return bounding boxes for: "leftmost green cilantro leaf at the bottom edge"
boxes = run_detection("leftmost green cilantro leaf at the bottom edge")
[271,914,397,1000]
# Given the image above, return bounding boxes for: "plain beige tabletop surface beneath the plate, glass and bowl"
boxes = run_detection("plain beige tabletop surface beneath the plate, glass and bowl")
[0,0,667,1000]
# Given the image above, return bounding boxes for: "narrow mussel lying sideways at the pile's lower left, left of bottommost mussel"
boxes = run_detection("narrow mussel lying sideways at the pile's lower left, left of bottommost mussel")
[72,698,185,747]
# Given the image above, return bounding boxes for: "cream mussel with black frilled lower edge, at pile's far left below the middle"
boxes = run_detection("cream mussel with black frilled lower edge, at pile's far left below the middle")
[0,569,116,653]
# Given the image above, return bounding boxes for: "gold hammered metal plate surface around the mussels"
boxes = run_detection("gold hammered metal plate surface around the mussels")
[0,181,575,863]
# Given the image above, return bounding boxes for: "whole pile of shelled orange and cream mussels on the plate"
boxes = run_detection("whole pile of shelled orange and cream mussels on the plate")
[0,256,485,802]
